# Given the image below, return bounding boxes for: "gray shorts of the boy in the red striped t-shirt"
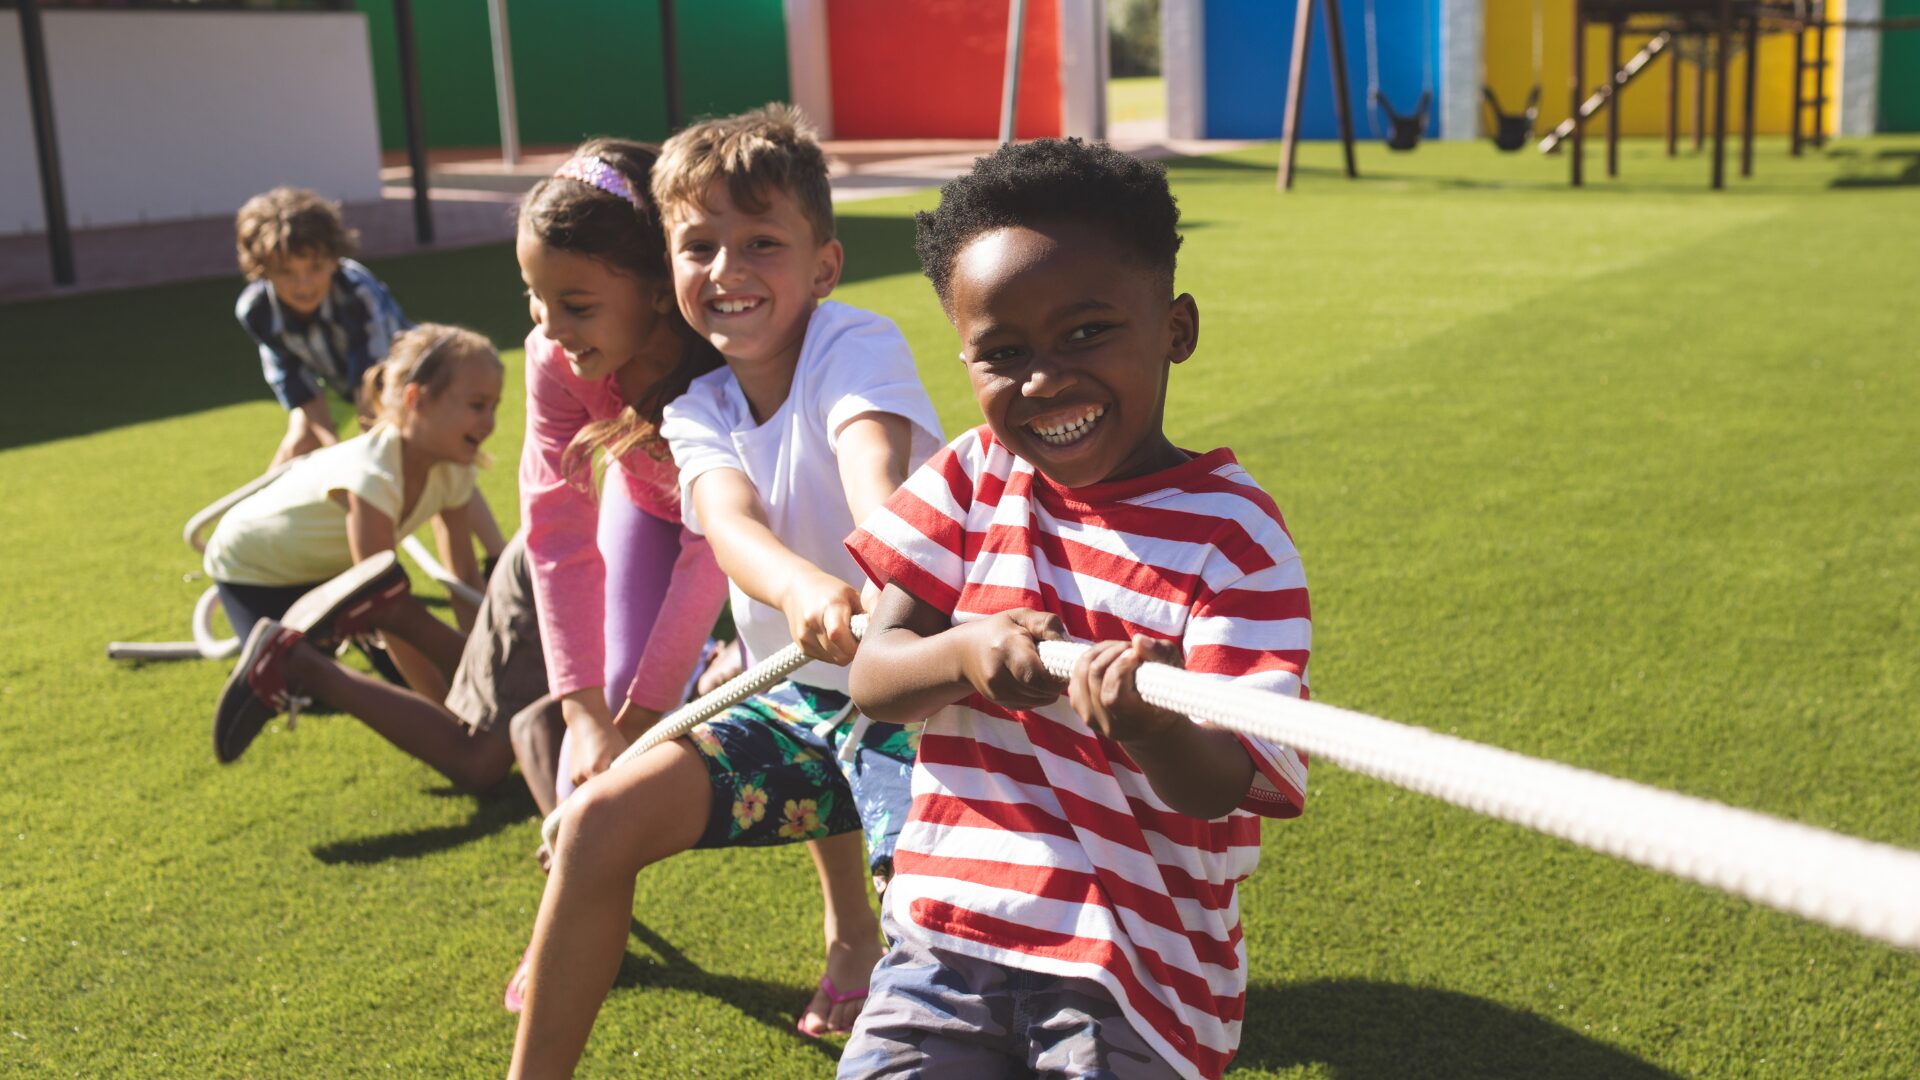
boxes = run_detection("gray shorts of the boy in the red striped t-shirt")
[839,919,1179,1080]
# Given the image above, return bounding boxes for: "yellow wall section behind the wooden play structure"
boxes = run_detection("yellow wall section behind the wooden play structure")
[1480,0,1845,135]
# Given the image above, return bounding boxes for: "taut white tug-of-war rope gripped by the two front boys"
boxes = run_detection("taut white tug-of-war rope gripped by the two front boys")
[543,628,1920,949]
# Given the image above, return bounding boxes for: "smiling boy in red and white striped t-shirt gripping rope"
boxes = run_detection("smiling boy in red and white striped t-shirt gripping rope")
[839,140,1309,1076]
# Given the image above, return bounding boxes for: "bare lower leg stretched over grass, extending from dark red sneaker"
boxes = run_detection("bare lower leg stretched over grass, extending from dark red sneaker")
[286,642,513,792]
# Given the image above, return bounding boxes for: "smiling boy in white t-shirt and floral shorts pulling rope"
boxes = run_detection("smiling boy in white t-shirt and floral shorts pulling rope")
[513,106,941,1076]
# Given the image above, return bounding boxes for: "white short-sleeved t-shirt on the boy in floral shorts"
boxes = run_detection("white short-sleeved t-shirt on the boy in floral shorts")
[660,300,945,692]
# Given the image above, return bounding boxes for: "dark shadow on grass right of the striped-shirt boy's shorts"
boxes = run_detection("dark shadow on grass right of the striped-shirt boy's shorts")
[1235,980,1672,1080]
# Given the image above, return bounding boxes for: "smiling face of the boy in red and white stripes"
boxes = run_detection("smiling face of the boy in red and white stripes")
[947,221,1200,488]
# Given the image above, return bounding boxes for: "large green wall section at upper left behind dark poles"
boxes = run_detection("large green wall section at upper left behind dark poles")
[355,0,787,150]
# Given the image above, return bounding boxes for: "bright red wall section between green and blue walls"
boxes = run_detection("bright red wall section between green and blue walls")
[828,0,1060,138]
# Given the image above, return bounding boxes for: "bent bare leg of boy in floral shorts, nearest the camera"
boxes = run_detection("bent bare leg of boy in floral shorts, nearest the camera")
[509,740,712,1076]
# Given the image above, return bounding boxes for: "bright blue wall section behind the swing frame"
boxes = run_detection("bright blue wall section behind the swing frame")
[1204,0,1440,138]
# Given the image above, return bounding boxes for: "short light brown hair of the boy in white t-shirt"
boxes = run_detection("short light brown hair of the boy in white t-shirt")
[653,102,833,244]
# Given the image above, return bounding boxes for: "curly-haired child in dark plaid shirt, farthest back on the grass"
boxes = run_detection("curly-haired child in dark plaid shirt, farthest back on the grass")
[234,186,413,465]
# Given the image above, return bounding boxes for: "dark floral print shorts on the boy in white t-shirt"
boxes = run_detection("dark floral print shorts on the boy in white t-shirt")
[687,682,920,882]
